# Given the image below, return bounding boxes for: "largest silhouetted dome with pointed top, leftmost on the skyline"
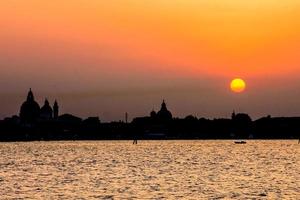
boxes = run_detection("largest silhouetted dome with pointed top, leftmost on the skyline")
[20,88,40,123]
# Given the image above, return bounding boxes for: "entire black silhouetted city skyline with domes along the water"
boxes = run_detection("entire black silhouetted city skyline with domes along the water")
[0,89,300,141]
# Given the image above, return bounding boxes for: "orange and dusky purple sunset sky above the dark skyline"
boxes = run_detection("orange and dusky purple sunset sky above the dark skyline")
[0,0,300,121]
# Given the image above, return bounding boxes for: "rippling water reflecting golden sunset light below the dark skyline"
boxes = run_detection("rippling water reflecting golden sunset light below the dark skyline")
[0,140,300,200]
